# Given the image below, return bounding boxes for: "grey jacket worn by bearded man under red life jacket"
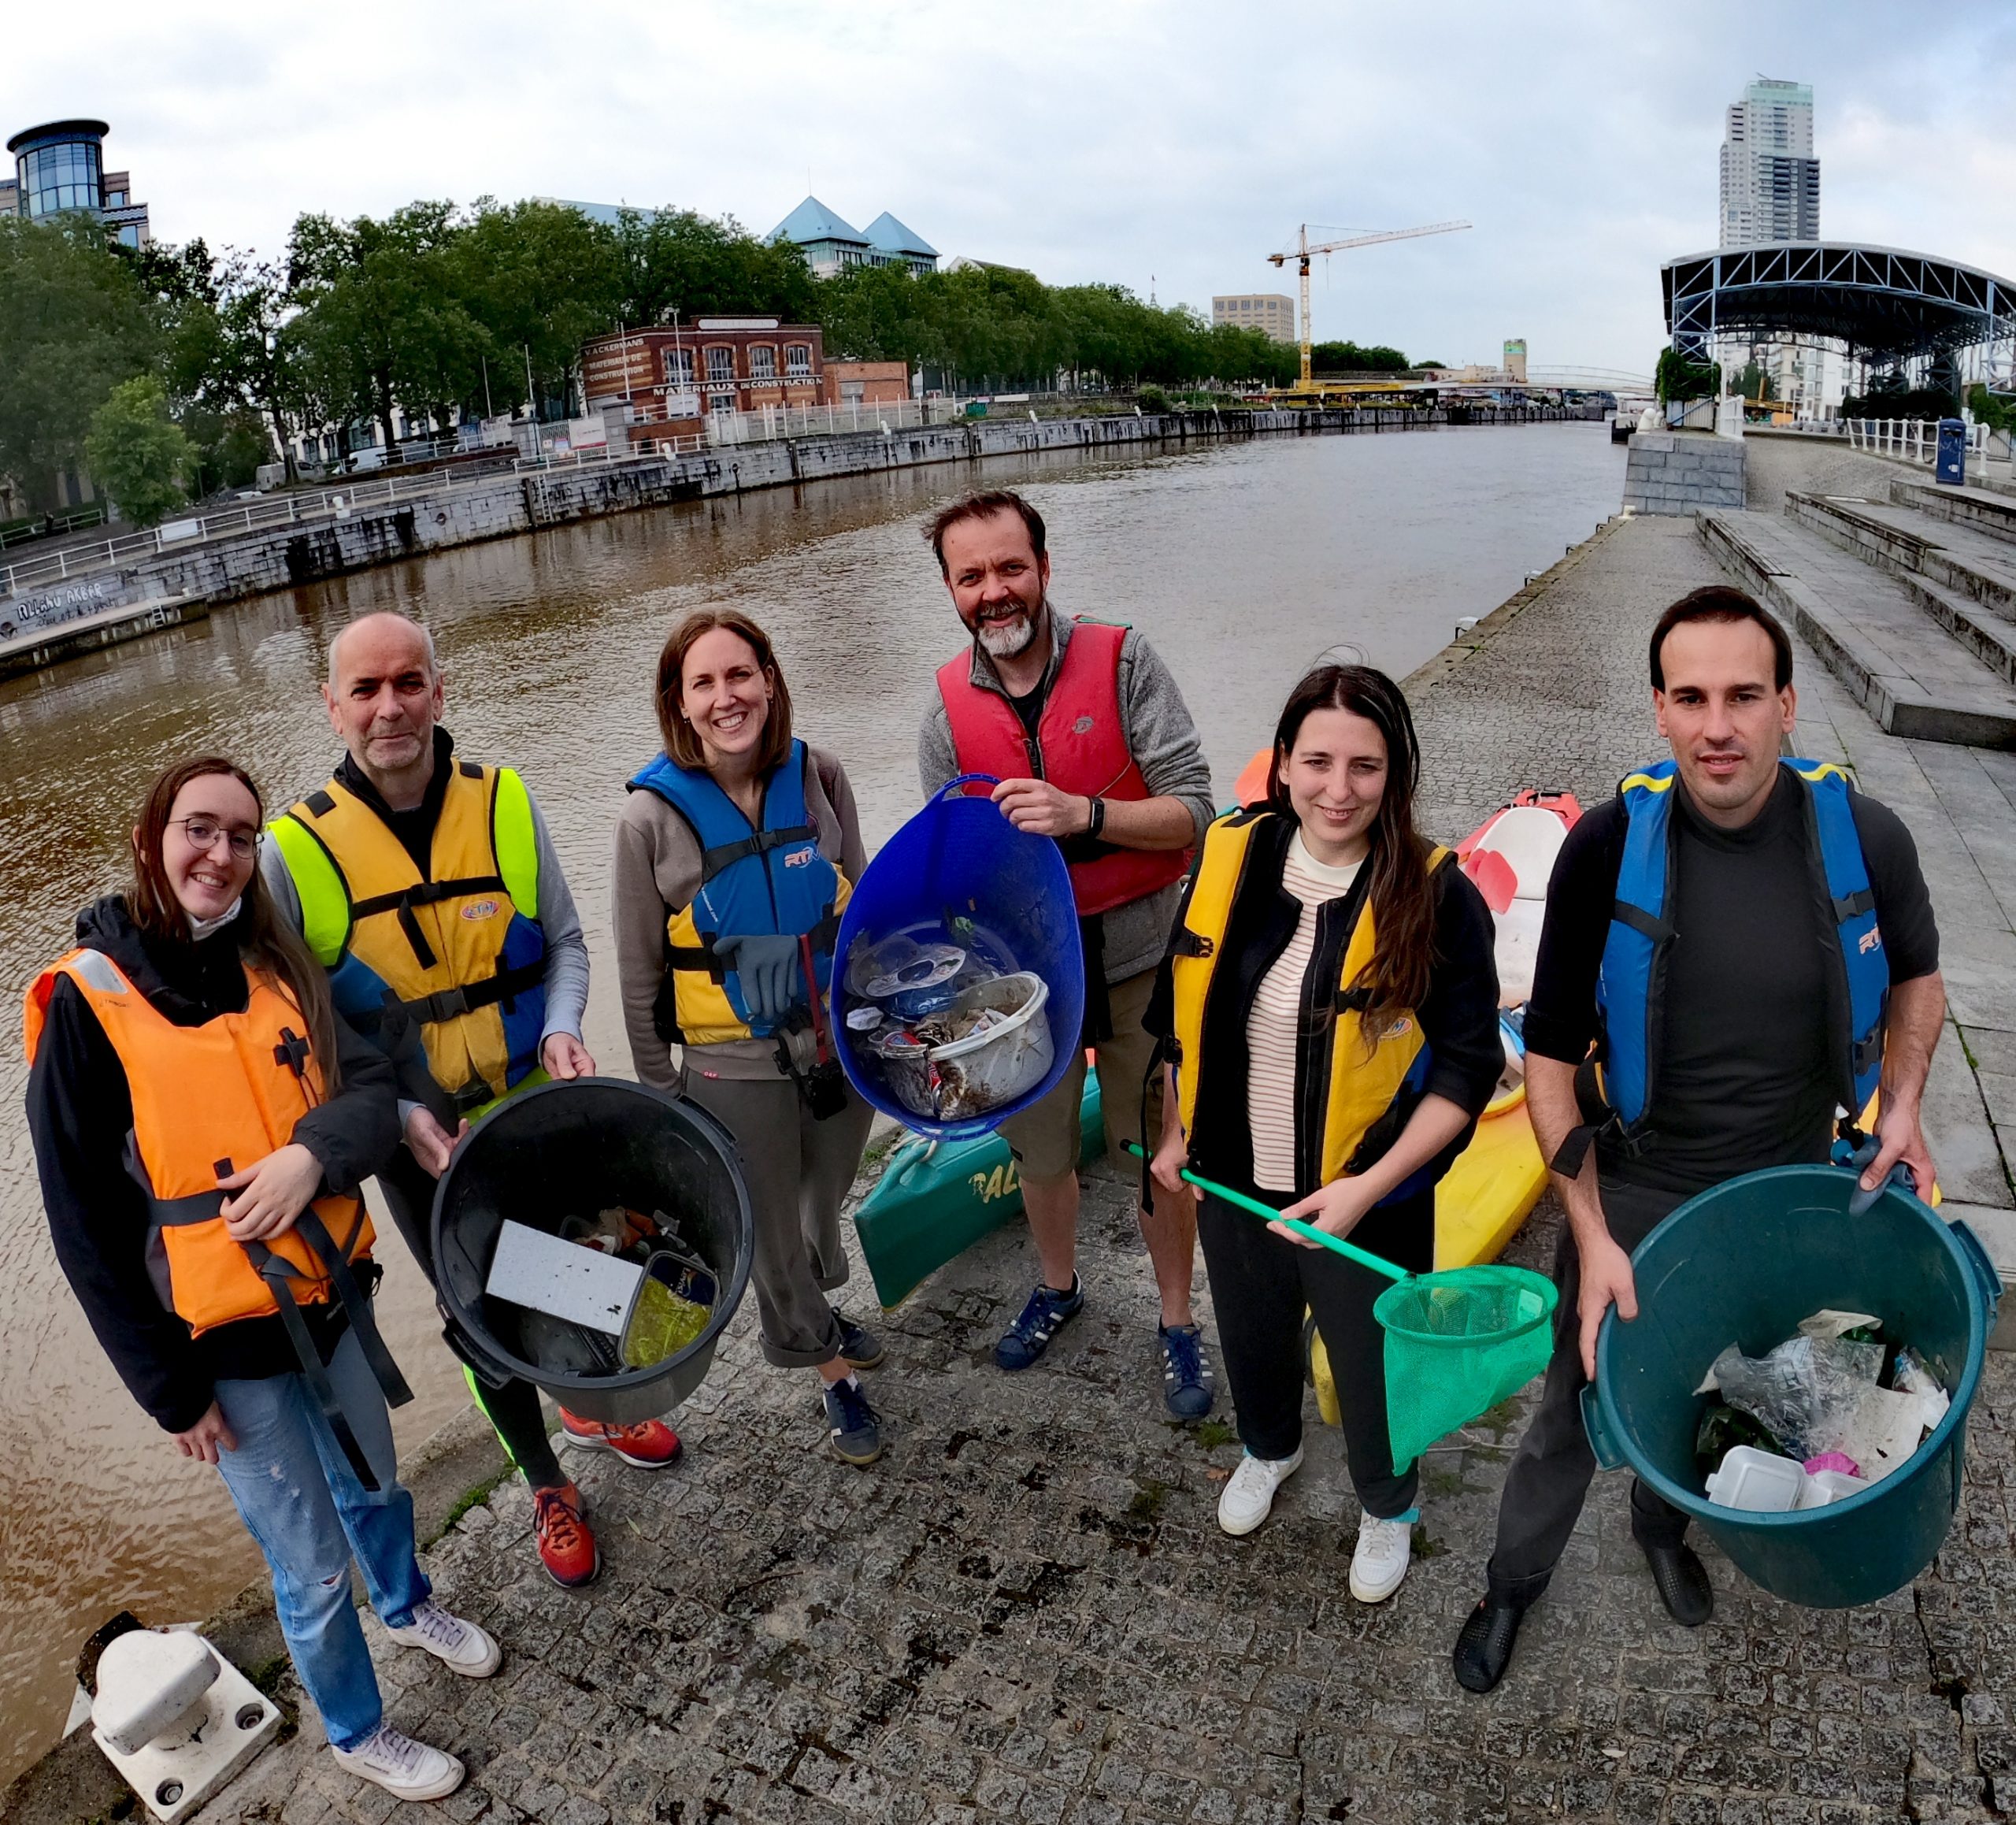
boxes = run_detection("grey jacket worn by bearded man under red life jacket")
[917,603,1217,982]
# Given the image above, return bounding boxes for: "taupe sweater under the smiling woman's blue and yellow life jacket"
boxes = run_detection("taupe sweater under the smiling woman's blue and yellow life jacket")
[611,744,867,1091]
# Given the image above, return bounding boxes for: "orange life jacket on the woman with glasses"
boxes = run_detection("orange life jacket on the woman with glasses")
[26,950,373,1337]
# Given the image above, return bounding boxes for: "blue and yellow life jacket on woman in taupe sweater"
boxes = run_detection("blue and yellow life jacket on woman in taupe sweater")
[629,740,850,1044]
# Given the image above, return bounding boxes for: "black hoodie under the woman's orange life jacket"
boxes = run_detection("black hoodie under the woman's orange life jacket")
[28,897,399,1432]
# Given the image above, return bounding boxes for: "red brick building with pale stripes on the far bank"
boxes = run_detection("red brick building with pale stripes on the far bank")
[580,317,827,429]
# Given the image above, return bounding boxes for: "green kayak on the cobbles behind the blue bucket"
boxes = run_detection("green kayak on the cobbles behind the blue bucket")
[854,1070,1106,1311]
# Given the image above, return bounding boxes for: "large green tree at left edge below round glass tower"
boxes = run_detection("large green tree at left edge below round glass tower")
[0,216,158,508]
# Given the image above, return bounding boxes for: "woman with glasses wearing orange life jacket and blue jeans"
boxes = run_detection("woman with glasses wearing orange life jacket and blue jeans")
[26,759,498,1801]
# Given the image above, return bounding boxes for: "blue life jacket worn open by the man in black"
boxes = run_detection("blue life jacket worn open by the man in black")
[1588,760,1889,1145]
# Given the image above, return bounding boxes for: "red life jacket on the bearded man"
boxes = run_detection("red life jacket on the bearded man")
[937,619,1189,918]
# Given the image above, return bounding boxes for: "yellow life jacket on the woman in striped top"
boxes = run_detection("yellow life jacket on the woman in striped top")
[1169,810,1450,1192]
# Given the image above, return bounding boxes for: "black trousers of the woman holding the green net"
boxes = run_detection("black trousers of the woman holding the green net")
[1198,1190,1436,1520]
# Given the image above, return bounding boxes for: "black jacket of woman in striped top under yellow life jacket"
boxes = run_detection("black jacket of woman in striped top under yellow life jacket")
[1143,817,1504,1198]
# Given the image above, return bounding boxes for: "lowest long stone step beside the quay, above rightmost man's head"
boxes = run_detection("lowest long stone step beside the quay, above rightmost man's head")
[1699,512,2016,748]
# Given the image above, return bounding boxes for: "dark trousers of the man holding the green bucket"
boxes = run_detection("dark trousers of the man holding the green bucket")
[1490,1181,1689,1603]
